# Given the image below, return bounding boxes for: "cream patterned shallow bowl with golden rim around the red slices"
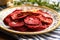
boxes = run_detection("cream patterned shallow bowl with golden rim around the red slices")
[0,5,60,35]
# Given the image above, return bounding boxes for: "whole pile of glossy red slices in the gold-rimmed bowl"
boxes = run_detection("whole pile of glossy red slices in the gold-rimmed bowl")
[3,9,53,32]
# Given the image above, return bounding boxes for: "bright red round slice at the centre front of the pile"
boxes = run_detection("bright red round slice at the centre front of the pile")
[24,16,41,24]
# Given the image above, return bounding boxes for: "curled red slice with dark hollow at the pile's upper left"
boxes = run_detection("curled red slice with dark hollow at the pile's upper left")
[11,10,27,20]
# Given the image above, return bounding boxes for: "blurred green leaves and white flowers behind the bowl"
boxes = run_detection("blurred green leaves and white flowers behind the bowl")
[13,0,60,11]
